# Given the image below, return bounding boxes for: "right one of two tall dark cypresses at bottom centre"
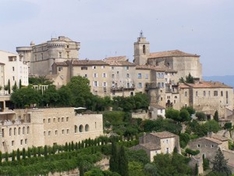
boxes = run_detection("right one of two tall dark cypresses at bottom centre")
[118,146,128,176]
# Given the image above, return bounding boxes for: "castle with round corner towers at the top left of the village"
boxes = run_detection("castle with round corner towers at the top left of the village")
[16,36,80,76]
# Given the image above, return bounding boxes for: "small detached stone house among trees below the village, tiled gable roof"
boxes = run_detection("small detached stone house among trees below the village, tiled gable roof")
[132,131,181,162]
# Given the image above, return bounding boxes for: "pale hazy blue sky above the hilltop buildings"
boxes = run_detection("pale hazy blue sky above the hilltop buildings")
[0,0,234,76]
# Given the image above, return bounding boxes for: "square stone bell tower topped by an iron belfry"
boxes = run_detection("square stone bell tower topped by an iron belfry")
[134,31,150,65]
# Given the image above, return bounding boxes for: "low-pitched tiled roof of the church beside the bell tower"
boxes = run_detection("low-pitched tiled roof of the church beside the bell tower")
[148,50,200,58]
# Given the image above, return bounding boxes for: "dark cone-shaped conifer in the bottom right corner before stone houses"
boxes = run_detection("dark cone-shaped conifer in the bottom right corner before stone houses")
[212,148,232,176]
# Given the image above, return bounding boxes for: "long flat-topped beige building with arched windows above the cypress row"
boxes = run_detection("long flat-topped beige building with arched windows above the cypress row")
[0,108,103,153]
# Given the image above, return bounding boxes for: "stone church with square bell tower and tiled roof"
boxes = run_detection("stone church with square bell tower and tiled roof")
[134,32,202,82]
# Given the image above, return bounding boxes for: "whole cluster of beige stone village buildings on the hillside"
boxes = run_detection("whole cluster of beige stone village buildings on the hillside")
[0,32,234,175]
